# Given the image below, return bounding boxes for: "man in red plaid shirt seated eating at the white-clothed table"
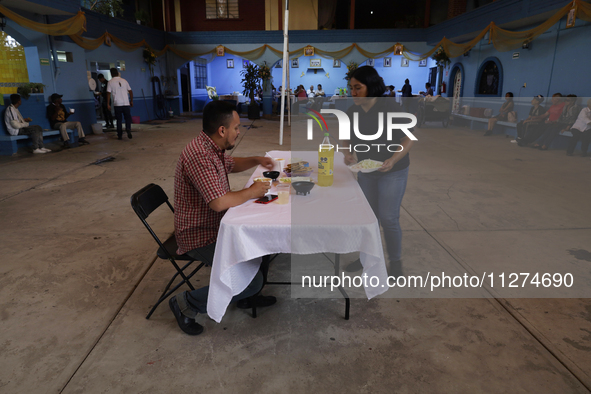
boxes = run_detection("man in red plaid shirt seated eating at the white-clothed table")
[169,101,276,335]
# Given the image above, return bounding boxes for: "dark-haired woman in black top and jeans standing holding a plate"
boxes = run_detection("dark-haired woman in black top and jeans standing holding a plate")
[345,66,413,276]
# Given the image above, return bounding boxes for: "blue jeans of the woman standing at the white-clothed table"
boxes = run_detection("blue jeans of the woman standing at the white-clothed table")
[358,167,408,262]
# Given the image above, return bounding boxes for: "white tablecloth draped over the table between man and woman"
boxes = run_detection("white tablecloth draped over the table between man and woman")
[207,151,387,323]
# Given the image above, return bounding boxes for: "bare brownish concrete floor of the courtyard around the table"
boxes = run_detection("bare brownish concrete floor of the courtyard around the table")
[0,120,591,393]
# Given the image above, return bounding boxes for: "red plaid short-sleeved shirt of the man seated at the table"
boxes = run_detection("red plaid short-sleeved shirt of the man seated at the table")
[174,131,234,254]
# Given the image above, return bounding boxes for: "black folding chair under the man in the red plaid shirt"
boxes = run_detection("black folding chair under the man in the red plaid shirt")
[131,183,211,319]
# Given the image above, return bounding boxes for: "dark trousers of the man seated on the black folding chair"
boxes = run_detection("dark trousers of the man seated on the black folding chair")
[176,242,268,319]
